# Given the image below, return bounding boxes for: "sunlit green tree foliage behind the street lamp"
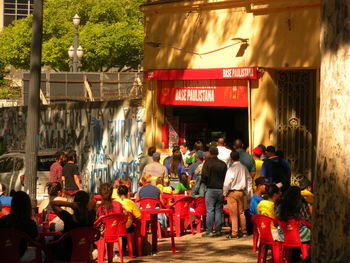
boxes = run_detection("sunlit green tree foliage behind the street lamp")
[0,0,144,71]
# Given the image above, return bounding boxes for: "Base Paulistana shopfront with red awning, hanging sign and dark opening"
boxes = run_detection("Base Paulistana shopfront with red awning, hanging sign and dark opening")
[144,67,260,151]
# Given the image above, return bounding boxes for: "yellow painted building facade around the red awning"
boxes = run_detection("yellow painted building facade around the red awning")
[141,0,320,153]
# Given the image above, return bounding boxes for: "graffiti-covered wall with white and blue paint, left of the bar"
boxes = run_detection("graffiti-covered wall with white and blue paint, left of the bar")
[0,102,145,193]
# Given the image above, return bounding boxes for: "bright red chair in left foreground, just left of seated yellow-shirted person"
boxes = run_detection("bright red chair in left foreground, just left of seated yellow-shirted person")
[95,213,133,263]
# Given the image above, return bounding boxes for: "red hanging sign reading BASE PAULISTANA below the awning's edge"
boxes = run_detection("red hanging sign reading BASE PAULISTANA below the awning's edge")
[157,79,248,107]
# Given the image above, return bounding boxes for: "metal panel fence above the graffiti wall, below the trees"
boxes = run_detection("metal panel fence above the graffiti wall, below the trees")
[23,72,143,105]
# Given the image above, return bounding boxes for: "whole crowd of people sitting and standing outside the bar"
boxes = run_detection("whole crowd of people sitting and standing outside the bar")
[0,138,313,260]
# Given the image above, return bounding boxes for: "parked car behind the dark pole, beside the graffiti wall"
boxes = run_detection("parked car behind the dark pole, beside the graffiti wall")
[0,151,56,200]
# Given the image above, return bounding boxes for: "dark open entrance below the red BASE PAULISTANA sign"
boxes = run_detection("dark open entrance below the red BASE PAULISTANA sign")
[165,106,249,148]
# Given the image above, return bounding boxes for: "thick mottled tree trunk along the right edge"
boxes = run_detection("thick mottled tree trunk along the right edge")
[312,0,350,263]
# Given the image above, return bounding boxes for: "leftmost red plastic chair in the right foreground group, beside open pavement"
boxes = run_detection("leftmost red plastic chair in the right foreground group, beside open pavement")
[252,215,281,263]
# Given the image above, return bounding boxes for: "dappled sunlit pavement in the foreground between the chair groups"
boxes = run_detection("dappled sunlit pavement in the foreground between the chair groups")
[124,228,257,263]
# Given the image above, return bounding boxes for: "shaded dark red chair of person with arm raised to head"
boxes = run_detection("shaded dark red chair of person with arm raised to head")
[47,227,100,263]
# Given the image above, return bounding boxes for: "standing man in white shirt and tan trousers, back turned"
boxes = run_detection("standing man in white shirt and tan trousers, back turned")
[223,150,252,239]
